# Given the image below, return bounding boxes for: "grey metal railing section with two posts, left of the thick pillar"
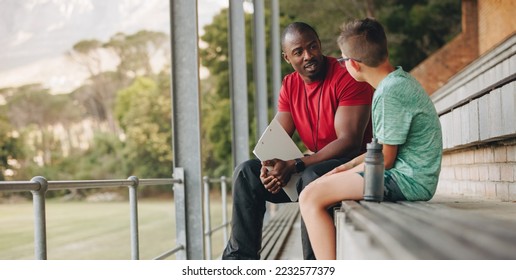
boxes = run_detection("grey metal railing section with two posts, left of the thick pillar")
[0,176,185,260]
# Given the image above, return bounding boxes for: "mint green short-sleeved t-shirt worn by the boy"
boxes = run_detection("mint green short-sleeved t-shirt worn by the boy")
[372,67,443,200]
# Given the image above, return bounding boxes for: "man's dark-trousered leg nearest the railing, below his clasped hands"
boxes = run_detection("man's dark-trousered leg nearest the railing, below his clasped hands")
[222,159,290,260]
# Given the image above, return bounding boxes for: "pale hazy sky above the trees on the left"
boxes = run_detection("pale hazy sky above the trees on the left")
[0,0,228,92]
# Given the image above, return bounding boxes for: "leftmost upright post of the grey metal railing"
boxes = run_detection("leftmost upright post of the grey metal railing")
[31,176,48,260]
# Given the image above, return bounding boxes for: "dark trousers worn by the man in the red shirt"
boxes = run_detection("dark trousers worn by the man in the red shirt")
[222,159,348,260]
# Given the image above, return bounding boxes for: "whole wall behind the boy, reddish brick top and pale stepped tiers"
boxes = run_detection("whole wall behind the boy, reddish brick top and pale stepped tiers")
[404,0,516,201]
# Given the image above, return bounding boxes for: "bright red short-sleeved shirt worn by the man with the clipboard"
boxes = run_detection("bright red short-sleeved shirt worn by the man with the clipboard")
[278,57,374,151]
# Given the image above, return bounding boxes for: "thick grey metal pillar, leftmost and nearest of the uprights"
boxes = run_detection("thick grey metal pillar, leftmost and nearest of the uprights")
[170,0,204,260]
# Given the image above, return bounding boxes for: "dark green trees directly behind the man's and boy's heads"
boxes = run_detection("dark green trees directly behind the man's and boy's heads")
[280,0,461,71]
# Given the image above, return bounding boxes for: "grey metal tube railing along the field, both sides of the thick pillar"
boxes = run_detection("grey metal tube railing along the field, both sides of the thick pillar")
[0,168,230,260]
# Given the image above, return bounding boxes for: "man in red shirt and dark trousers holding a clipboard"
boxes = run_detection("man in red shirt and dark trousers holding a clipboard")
[222,22,373,259]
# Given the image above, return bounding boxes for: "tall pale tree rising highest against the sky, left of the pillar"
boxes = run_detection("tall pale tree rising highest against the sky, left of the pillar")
[68,30,170,135]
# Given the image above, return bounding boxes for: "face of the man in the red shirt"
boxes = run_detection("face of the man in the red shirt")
[283,32,323,80]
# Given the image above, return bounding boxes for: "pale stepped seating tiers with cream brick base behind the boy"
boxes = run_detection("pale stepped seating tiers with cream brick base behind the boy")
[430,35,516,201]
